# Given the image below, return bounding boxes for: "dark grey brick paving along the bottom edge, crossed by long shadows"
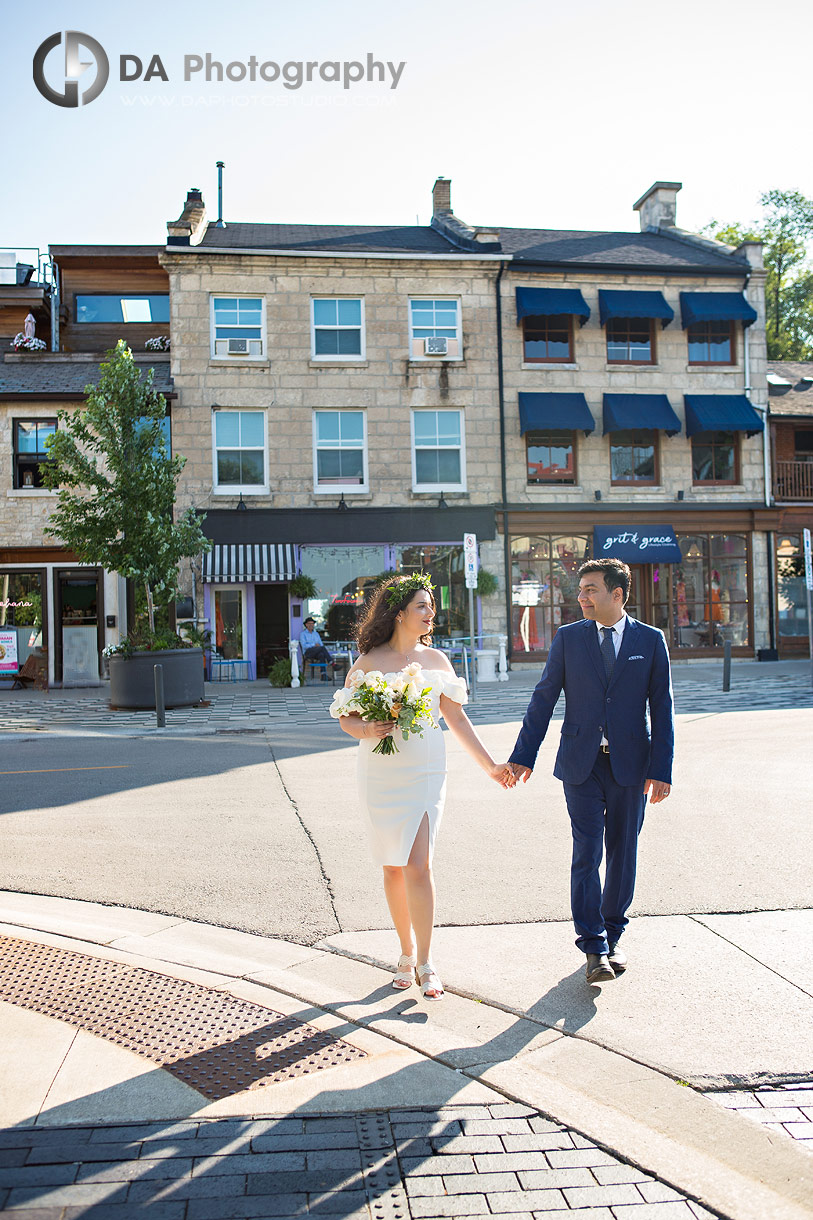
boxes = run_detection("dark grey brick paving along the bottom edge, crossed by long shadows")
[0,1104,714,1220]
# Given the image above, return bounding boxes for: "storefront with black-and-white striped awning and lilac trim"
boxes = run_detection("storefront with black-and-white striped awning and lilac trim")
[201,508,496,677]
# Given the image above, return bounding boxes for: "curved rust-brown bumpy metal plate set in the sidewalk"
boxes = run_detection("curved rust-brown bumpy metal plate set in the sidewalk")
[0,936,367,1100]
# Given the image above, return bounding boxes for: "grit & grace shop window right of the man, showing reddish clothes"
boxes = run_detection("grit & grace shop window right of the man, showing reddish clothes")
[673,534,750,648]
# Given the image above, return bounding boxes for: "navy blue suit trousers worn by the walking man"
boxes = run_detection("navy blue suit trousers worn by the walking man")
[564,750,646,953]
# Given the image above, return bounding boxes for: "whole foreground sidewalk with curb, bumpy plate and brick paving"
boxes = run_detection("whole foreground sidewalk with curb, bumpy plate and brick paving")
[0,893,813,1220]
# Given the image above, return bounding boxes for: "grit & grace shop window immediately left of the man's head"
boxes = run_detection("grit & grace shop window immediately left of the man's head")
[511,534,590,653]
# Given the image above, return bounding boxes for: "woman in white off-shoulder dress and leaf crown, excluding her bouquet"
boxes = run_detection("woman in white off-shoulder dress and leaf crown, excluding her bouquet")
[339,572,514,999]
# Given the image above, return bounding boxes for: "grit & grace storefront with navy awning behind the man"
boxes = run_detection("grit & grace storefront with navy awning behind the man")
[509,511,767,661]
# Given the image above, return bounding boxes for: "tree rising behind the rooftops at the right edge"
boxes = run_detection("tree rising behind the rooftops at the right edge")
[704,190,813,360]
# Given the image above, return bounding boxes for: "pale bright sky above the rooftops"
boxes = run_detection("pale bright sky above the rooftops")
[0,0,813,264]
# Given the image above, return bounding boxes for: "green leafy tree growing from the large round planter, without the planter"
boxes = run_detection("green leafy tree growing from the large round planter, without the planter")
[42,339,211,633]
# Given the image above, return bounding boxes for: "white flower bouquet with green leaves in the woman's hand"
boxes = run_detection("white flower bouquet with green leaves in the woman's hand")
[330,661,437,754]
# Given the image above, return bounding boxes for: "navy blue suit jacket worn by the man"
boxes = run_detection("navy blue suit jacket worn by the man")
[510,619,675,786]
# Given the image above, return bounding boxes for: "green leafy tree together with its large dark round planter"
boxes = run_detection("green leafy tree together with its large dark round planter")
[42,339,211,708]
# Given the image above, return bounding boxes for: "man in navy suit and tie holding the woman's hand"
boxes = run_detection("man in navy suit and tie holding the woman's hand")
[509,559,674,983]
